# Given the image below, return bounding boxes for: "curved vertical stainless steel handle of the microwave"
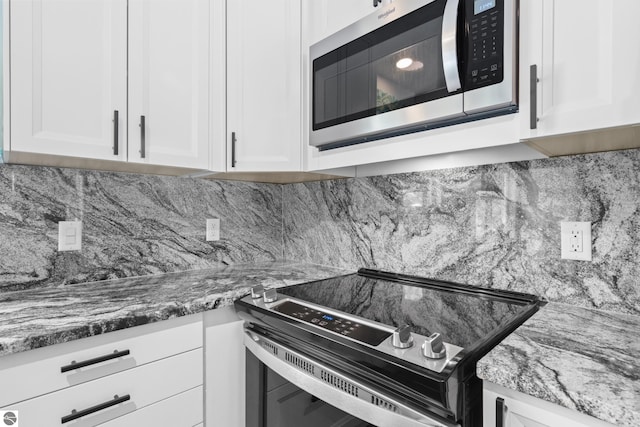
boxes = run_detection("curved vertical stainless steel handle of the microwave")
[442,0,462,92]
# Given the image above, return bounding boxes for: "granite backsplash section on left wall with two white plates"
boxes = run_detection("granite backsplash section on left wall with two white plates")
[0,165,282,289]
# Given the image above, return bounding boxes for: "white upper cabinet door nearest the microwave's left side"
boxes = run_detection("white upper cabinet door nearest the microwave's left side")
[227,0,302,172]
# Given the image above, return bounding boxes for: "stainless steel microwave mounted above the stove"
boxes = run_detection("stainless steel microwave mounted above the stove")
[309,0,518,150]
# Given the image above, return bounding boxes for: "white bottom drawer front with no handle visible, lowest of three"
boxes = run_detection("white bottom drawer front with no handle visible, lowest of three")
[100,386,203,427]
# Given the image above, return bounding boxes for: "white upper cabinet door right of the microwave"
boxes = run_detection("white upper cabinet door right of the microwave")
[521,0,640,137]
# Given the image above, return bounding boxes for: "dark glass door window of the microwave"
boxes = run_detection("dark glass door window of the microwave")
[313,0,449,130]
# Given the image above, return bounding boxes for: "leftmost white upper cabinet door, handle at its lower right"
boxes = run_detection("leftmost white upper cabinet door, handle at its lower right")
[10,0,127,160]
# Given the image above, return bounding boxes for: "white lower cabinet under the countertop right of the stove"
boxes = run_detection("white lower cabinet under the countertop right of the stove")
[482,381,613,427]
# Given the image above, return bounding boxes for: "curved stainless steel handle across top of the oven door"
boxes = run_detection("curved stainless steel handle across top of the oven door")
[244,330,459,427]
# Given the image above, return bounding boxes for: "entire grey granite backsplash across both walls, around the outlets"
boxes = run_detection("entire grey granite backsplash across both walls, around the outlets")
[0,150,640,314]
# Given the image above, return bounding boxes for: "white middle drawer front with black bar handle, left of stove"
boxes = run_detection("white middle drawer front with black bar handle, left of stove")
[2,349,203,427]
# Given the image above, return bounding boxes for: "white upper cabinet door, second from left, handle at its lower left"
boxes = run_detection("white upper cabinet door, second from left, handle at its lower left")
[129,0,210,169]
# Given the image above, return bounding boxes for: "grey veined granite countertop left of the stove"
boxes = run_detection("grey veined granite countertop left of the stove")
[0,261,352,356]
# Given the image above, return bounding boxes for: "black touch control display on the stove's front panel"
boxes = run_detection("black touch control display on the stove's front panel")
[273,301,391,346]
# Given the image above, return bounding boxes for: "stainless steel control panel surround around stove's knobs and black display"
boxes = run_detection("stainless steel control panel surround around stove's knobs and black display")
[243,294,464,373]
